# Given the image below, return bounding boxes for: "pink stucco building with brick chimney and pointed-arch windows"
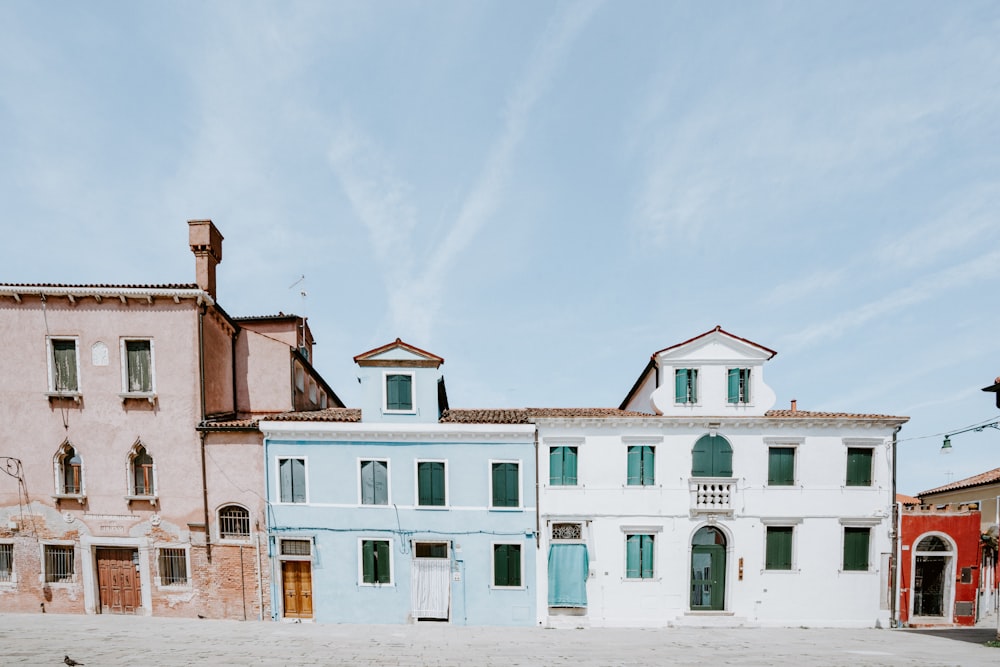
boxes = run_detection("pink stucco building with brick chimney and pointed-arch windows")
[0,220,342,618]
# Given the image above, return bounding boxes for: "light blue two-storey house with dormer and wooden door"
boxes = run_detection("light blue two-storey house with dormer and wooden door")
[260,339,538,625]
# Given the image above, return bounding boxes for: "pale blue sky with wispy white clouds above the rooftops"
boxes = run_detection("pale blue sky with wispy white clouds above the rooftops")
[0,0,1000,494]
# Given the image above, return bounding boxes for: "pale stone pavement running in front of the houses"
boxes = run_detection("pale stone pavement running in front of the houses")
[0,614,1000,667]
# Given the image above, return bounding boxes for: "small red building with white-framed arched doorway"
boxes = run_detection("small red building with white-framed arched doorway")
[899,504,983,626]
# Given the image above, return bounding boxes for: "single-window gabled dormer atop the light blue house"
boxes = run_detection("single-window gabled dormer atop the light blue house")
[354,338,448,423]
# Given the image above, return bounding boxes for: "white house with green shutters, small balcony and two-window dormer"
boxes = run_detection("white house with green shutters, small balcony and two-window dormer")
[528,327,907,627]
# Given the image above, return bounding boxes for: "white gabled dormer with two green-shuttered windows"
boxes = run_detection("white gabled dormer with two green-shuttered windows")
[621,327,777,416]
